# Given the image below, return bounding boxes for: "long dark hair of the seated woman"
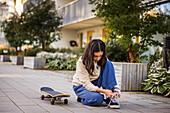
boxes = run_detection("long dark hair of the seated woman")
[82,39,107,75]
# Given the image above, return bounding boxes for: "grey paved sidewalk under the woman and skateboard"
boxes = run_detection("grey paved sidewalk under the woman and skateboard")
[0,62,170,113]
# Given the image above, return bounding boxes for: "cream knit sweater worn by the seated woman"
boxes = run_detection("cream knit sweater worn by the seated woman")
[72,57,101,91]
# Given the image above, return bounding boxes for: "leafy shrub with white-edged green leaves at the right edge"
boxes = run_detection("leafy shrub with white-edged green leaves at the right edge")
[142,58,170,96]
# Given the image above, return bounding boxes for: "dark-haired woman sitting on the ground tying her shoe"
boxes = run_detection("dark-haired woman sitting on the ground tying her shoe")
[72,39,120,108]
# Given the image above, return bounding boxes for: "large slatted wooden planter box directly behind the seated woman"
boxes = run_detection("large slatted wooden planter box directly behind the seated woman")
[112,62,147,91]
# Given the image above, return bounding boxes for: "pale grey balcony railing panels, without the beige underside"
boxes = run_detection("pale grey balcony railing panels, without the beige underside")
[58,0,95,26]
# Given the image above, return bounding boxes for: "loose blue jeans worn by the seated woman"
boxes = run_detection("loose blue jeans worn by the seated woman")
[73,61,117,105]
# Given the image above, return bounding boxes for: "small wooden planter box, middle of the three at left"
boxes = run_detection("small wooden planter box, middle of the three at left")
[12,56,24,65]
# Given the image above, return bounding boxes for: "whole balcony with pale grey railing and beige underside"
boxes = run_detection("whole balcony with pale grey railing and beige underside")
[58,0,102,29]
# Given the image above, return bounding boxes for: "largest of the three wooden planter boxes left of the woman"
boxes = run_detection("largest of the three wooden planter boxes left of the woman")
[24,57,46,69]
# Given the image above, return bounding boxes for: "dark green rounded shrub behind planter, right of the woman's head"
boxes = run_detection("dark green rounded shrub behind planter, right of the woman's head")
[106,39,129,62]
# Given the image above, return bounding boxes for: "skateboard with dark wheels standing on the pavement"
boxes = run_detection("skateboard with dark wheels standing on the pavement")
[40,87,70,105]
